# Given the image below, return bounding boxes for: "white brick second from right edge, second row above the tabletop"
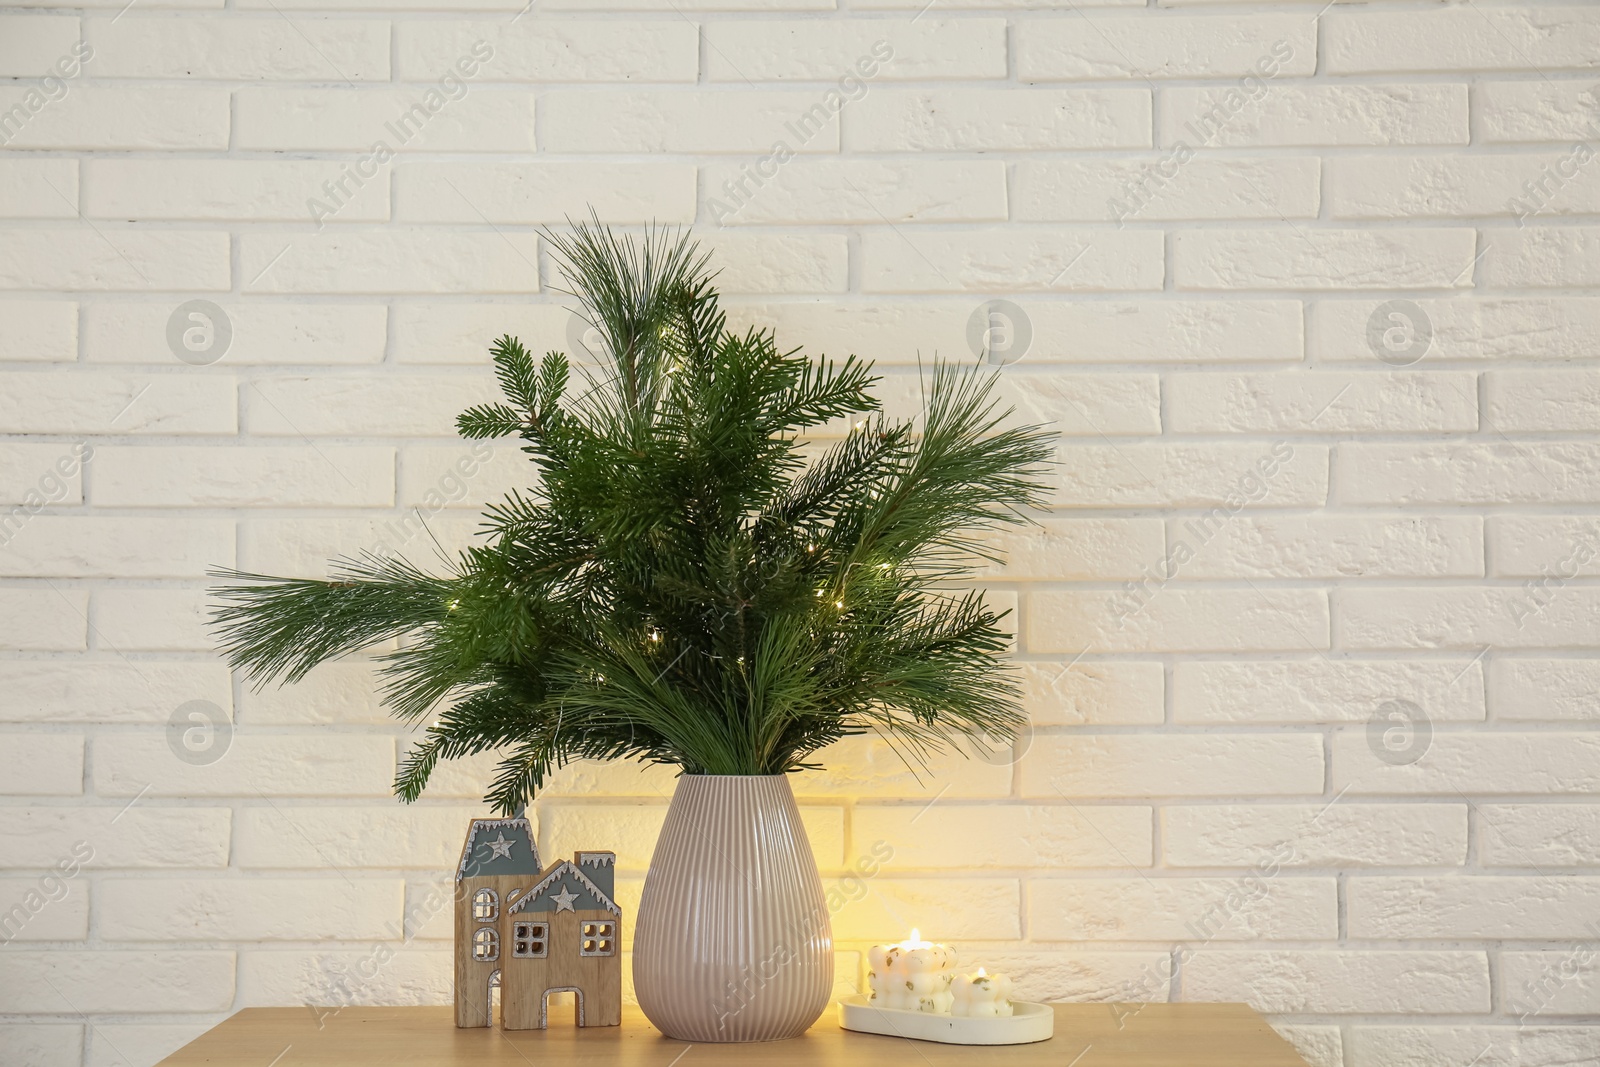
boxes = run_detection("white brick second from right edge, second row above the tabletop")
[1027,883,1338,950]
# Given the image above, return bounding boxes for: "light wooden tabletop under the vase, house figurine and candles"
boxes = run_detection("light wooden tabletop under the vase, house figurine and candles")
[160,1005,1306,1067]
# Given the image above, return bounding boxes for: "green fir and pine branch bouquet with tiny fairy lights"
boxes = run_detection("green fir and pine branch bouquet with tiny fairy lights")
[213,222,1051,813]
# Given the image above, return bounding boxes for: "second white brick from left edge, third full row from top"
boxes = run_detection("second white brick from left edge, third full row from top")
[83,158,389,222]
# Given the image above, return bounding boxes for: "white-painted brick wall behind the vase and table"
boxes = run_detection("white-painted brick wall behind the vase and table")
[0,0,1600,1067]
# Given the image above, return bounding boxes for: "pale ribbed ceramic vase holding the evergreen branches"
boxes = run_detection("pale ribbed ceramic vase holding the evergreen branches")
[634,774,834,1041]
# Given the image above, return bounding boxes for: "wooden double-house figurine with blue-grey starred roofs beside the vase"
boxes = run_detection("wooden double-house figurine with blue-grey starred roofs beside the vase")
[456,819,622,1030]
